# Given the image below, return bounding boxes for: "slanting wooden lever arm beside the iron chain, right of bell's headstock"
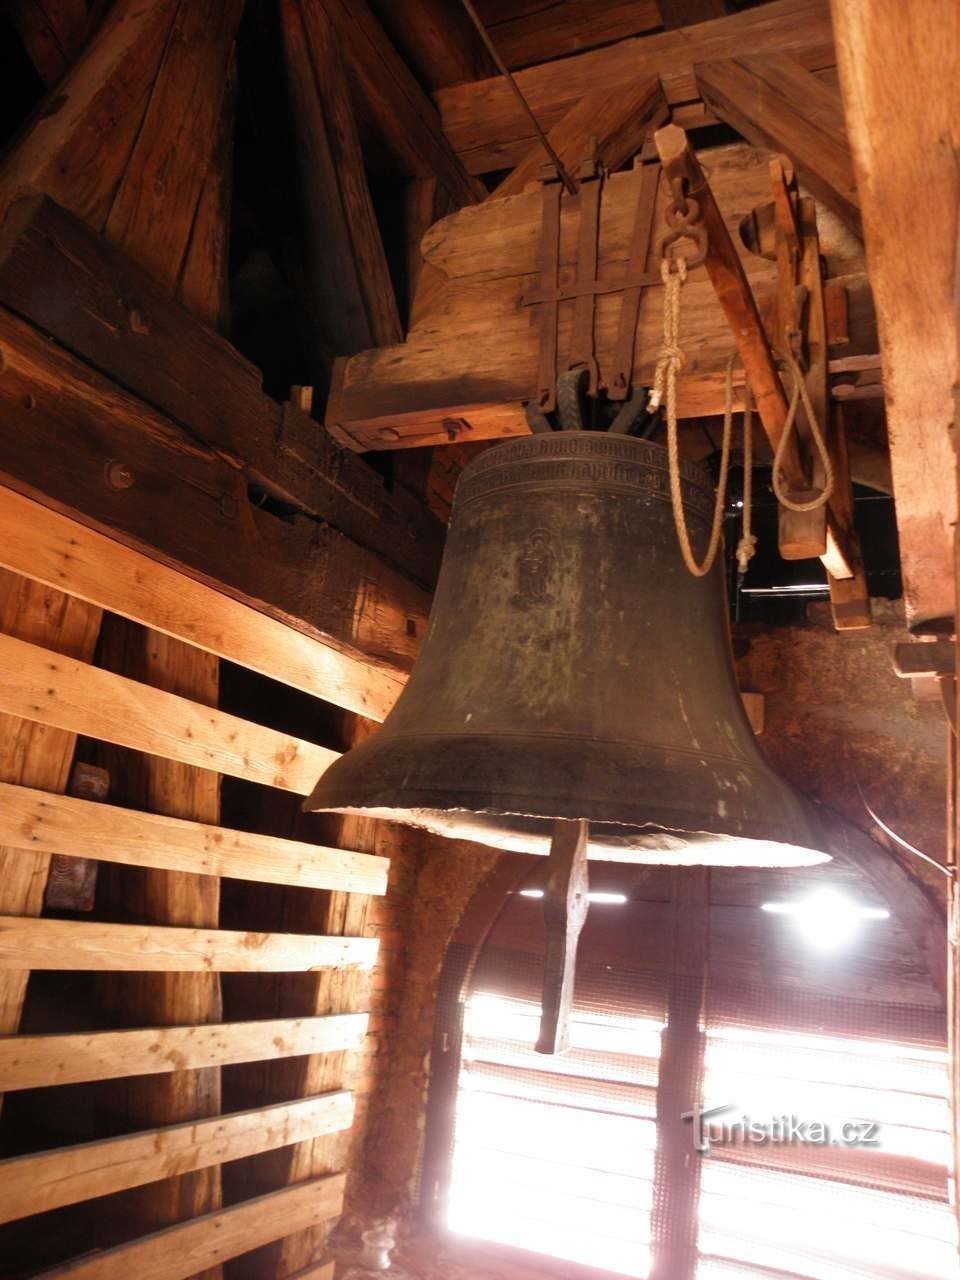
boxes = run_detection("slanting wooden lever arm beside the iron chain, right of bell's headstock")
[654,124,852,577]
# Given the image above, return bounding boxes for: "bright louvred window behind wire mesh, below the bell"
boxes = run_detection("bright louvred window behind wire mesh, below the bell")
[435,884,960,1280]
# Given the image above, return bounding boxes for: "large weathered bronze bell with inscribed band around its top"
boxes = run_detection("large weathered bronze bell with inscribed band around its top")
[306,431,828,867]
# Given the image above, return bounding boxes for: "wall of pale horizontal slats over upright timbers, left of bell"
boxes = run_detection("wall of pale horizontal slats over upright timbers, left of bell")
[0,490,389,1280]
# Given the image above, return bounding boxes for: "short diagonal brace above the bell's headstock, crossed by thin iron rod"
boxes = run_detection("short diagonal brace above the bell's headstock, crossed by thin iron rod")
[490,76,669,198]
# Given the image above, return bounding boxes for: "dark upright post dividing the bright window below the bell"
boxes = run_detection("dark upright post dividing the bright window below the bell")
[650,867,710,1280]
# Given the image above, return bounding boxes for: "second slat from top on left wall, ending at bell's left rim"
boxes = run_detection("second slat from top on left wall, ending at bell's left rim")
[0,636,338,795]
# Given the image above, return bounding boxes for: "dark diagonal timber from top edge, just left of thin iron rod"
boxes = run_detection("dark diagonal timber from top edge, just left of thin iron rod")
[321,0,485,207]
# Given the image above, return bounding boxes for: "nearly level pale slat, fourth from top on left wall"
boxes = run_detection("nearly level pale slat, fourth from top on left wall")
[0,915,378,973]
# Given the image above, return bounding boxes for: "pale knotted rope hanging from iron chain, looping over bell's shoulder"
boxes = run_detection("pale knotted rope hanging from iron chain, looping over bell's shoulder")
[649,257,733,577]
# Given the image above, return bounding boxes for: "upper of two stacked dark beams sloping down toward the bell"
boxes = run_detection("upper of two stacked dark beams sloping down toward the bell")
[0,197,440,586]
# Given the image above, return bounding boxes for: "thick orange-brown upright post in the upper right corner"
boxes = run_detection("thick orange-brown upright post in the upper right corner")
[832,0,960,630]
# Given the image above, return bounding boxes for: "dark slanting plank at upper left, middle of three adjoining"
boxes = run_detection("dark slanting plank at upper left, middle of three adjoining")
[105,0,243,297]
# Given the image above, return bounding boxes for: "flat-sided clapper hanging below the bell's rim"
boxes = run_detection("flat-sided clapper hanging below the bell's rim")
[536,818,590,1053]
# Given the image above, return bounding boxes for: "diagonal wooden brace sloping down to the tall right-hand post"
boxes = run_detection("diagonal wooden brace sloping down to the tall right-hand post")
[696,54,863,239]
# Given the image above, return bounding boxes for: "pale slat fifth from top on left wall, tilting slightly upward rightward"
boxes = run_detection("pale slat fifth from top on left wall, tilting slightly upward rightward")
[0,1014,367,1092]
